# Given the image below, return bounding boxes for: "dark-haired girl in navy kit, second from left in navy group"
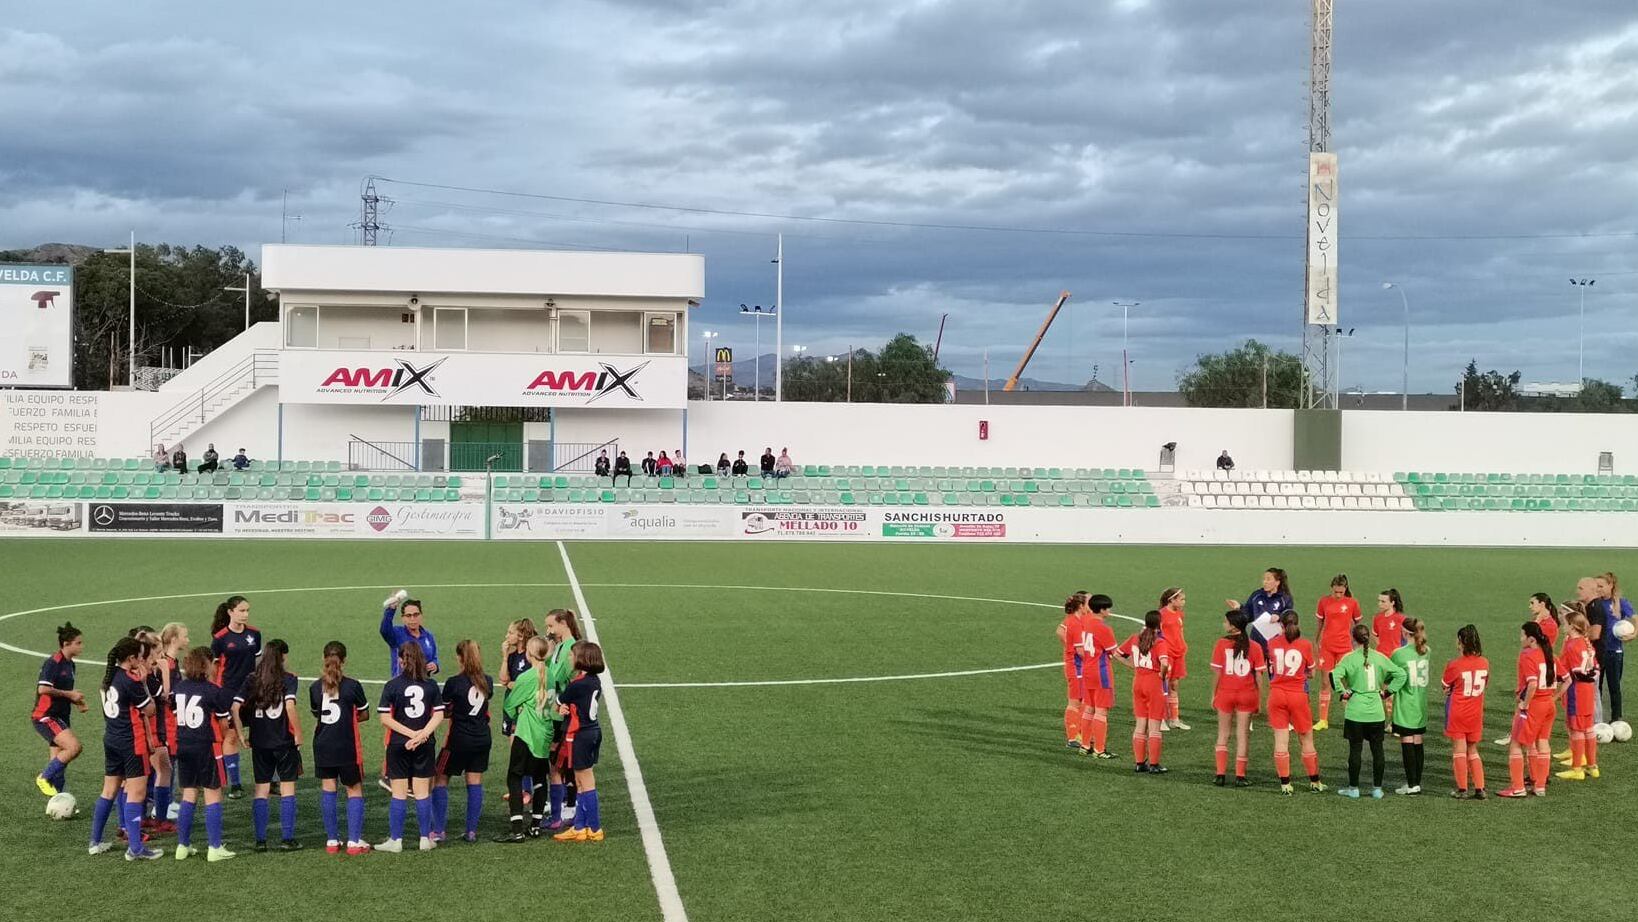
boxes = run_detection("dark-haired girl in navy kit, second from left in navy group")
[90,637,162,861]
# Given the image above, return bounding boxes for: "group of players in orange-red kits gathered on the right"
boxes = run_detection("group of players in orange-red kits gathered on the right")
[1058,568,1638,799]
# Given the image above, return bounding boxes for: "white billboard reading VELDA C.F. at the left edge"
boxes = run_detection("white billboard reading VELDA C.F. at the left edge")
[0,264,74,388]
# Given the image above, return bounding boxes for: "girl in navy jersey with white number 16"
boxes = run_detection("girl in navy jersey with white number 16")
[170,647,234,861]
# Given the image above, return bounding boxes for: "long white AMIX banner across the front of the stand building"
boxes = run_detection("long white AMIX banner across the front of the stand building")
[278,349,688,409]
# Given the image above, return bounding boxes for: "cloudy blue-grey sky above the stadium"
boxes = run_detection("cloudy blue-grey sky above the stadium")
[0,0,1638,391]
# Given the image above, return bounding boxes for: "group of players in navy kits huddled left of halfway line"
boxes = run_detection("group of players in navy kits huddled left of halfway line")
[31,590,604,861]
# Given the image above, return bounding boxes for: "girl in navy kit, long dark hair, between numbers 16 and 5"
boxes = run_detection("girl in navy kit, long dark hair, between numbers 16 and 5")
[233,640,301,852]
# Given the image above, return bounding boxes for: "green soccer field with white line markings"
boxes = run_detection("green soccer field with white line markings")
[0,540,1638,922]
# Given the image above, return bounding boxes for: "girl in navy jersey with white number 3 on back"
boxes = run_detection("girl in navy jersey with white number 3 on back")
[375,640,444,852]
